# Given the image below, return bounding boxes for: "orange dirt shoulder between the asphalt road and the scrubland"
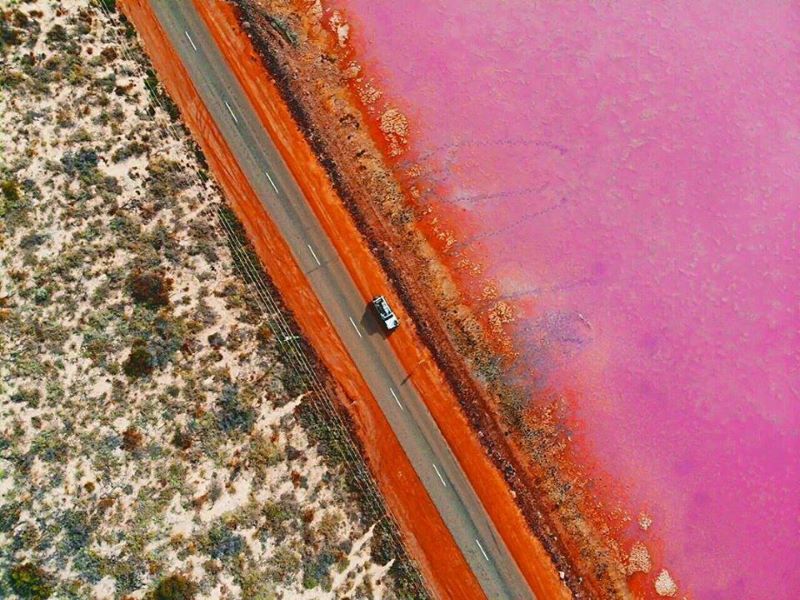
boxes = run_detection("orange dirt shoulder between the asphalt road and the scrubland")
[120,0,484,599]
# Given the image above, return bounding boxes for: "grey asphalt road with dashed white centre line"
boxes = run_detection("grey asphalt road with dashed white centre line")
[151,0,534,600]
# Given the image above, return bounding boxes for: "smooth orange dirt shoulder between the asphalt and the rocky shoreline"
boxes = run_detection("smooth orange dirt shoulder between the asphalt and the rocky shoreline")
[195,0,569,598]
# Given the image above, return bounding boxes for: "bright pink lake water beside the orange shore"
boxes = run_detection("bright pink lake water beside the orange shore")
[337,0,800,599]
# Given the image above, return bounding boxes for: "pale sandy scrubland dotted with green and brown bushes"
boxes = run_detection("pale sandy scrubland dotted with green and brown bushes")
[0,0,424,600]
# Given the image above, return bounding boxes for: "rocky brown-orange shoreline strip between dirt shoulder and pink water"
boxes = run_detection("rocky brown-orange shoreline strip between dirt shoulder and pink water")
[220,2,640,597]
